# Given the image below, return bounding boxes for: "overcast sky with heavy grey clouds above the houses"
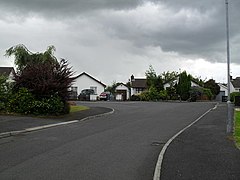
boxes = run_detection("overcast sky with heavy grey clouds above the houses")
[0,0,240,85]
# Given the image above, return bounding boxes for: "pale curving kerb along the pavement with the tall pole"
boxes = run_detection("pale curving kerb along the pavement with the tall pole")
[153,103,219,180]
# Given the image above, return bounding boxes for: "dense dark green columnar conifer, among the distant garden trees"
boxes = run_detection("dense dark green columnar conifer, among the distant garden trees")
[177,71,191,101]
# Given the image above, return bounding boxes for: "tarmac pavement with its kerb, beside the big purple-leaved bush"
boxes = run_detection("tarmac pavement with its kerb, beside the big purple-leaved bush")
[0,107,113,138]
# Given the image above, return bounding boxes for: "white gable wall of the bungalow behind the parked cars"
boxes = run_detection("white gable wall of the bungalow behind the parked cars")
[72,75,104,96]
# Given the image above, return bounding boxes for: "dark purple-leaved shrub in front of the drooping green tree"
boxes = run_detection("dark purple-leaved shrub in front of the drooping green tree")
[14,59,73,101]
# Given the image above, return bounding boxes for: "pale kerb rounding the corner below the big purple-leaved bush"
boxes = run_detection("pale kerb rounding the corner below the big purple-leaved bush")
[0,108,115,139]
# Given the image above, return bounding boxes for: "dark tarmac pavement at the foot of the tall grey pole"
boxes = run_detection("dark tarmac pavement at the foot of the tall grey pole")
[161,104,240,180]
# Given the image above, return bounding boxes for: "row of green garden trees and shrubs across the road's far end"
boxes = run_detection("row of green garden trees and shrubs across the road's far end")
[134,66,220,101]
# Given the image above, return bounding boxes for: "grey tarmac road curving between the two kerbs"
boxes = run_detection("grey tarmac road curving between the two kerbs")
[0,102,215,180]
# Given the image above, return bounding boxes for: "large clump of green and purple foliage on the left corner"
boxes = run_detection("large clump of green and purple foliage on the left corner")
[6,45,74,114]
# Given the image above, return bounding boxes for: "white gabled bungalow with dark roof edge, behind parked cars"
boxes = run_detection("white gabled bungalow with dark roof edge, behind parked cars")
[71,72,106,96]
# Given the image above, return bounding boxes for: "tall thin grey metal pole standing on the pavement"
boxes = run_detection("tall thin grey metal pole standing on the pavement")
[225,0,233,134]
